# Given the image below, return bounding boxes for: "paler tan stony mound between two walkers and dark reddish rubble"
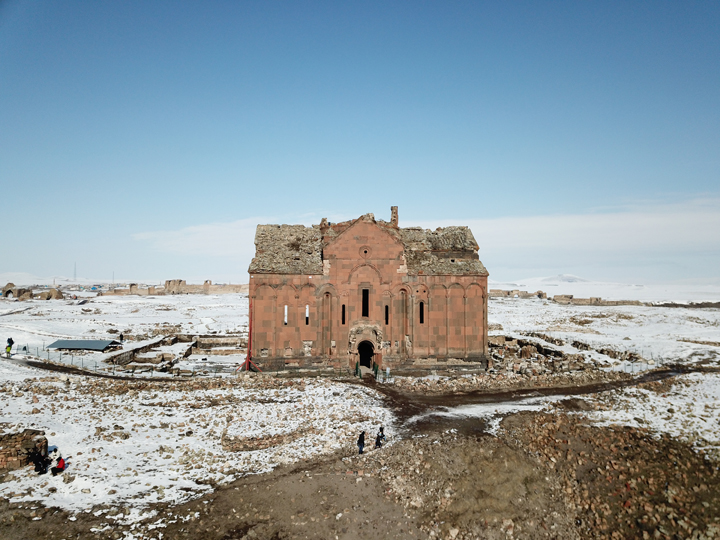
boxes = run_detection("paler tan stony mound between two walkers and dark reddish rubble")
[343,430,579,540]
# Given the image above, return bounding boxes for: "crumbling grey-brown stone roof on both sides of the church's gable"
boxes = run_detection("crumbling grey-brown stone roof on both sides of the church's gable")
[248,210,488,276]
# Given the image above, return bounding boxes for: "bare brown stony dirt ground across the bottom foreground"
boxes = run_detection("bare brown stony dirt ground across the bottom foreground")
[0,374,720,540]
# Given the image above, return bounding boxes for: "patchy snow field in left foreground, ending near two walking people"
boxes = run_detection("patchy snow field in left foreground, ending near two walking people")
[0,359,393,521]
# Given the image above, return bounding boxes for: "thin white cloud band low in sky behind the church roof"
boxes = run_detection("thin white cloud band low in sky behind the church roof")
[133,198,720,280]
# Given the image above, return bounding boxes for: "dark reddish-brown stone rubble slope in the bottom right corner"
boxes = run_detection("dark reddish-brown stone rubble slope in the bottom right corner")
[502,412,720,539]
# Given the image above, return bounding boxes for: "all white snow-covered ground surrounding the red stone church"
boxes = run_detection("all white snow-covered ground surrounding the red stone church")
[0,280,720,520]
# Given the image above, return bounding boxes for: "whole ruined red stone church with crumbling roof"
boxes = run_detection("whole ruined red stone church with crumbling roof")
[249,207,488,369]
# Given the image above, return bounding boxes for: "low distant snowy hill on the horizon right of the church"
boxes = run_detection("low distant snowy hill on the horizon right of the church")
[488,274,720,303]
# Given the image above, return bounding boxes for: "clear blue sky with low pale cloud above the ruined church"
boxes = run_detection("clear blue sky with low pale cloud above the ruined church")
[0,0,720,281]
